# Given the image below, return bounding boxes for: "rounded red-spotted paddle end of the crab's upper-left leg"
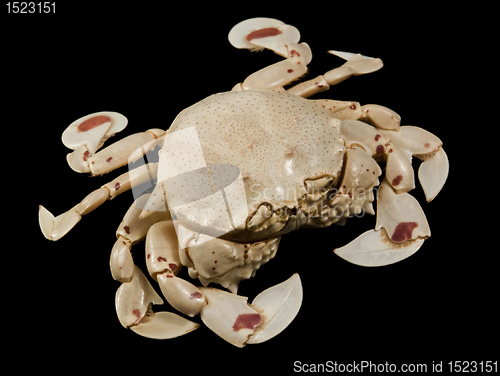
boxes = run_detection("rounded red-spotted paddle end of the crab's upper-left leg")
[62,111,128,172]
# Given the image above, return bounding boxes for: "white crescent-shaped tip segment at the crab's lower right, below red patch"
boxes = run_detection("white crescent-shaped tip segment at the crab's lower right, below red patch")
[334,230,424,266]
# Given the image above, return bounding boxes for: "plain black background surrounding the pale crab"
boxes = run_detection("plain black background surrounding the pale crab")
[1,1,499,374]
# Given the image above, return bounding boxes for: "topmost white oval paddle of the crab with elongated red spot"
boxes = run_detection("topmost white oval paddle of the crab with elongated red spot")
[228,18,300,57]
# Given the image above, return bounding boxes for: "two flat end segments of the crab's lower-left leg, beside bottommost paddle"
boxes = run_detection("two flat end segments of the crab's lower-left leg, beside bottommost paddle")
[115,266,199,339]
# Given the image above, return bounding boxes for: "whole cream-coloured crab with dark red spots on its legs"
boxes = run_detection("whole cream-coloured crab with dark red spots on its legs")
[39,18,448,347]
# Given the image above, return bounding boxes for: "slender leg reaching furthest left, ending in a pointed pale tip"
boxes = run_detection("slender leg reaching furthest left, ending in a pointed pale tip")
[38,163,158,240]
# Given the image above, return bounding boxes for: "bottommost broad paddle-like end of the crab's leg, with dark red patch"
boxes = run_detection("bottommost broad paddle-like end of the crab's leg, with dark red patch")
[200,274,302,347]
